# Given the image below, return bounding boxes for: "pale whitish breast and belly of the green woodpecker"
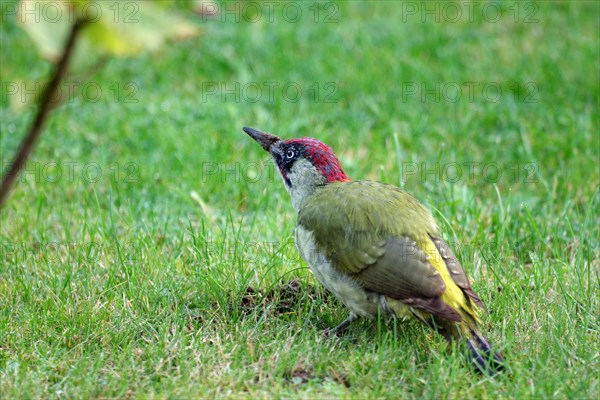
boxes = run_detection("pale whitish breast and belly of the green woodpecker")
[296,225,387,317]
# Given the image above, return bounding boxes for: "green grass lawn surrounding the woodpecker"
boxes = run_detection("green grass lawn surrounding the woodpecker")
[0,1,600,399]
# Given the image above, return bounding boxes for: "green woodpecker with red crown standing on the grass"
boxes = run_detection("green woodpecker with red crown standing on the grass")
[244,128,503,374]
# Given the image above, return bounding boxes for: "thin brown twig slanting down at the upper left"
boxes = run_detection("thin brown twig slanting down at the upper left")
[0,19,88,209]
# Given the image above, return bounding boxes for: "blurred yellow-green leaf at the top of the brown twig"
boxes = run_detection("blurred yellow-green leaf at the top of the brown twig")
[18,0,199,61]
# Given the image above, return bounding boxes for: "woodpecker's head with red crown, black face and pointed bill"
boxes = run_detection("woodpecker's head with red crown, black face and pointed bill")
[244,128,349,208]
